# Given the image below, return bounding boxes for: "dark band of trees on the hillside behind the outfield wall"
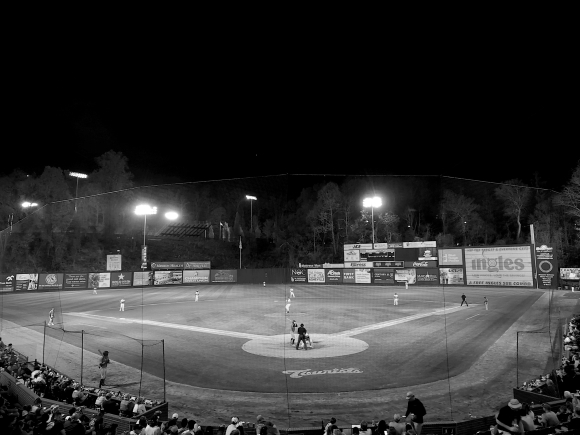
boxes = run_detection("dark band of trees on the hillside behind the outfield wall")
[0,151,580,272]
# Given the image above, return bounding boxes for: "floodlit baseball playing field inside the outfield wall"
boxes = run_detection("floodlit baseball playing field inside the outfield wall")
[1,284,578,427]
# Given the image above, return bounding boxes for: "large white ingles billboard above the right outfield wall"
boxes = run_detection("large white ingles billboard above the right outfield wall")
[464,246,534,287]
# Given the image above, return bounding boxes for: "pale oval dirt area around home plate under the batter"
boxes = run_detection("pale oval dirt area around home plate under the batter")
[242,334,369,359]
